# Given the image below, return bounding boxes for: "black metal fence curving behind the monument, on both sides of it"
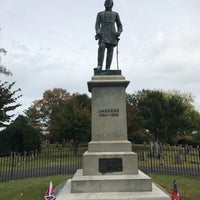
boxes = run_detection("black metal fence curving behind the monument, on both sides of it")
[0,143,200,182]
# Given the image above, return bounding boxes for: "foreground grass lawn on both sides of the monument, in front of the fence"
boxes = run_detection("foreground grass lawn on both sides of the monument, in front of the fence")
[0,175,200,200]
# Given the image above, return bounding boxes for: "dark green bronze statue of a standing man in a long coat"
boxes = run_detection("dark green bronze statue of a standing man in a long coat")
[95,0,122,70]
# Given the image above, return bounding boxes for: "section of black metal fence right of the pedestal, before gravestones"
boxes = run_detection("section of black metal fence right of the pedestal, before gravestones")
[133,143,200,177]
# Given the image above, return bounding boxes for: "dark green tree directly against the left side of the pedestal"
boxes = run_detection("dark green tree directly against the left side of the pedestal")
[52,94,91,149]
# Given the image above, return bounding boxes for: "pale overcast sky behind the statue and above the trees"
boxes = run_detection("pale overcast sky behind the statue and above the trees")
[0,0,200,113]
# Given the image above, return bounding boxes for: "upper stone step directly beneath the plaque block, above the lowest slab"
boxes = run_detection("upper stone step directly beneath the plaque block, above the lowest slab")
[71,169,152,193]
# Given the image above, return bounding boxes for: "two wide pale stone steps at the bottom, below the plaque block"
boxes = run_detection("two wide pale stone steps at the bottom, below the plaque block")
[56,170,170,200]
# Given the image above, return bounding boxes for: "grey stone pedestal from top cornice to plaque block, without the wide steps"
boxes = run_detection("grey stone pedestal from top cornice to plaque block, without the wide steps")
[83,75,138,176]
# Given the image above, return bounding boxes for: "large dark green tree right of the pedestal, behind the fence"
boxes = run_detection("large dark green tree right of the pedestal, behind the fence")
[128,90,200,142]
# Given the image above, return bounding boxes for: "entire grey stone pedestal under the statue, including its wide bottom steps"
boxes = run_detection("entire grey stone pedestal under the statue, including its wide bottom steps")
[57,74,170,200]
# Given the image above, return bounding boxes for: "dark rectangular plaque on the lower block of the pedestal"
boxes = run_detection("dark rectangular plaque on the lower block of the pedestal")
[99,158,123,173]
